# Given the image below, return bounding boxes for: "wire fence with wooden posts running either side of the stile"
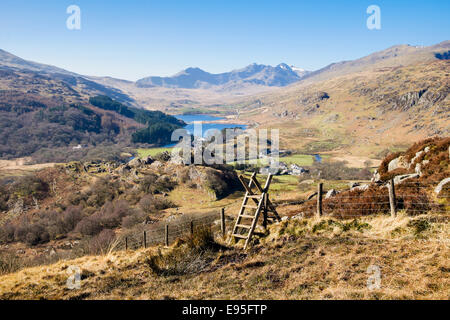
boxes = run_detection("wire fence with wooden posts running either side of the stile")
[117,181,450,250]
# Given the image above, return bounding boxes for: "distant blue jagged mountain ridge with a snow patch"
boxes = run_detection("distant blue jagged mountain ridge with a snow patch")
[136,63,307,89]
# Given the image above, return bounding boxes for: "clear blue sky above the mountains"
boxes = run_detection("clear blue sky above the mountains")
[0,0,450,80]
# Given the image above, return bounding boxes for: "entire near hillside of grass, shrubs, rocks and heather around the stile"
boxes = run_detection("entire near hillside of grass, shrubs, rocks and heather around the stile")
[0,138,450,300]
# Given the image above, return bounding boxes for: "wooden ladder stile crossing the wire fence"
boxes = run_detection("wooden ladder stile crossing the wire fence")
[230,172,281,249]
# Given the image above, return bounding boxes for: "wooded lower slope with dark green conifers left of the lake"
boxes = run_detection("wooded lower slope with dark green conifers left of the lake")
[0,90,184,162]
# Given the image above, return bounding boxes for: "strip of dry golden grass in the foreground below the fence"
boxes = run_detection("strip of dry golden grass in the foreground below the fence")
[0,216,450,299]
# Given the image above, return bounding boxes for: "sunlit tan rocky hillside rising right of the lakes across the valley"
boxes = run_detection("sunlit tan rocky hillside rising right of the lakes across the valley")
[232,42,450,158]
